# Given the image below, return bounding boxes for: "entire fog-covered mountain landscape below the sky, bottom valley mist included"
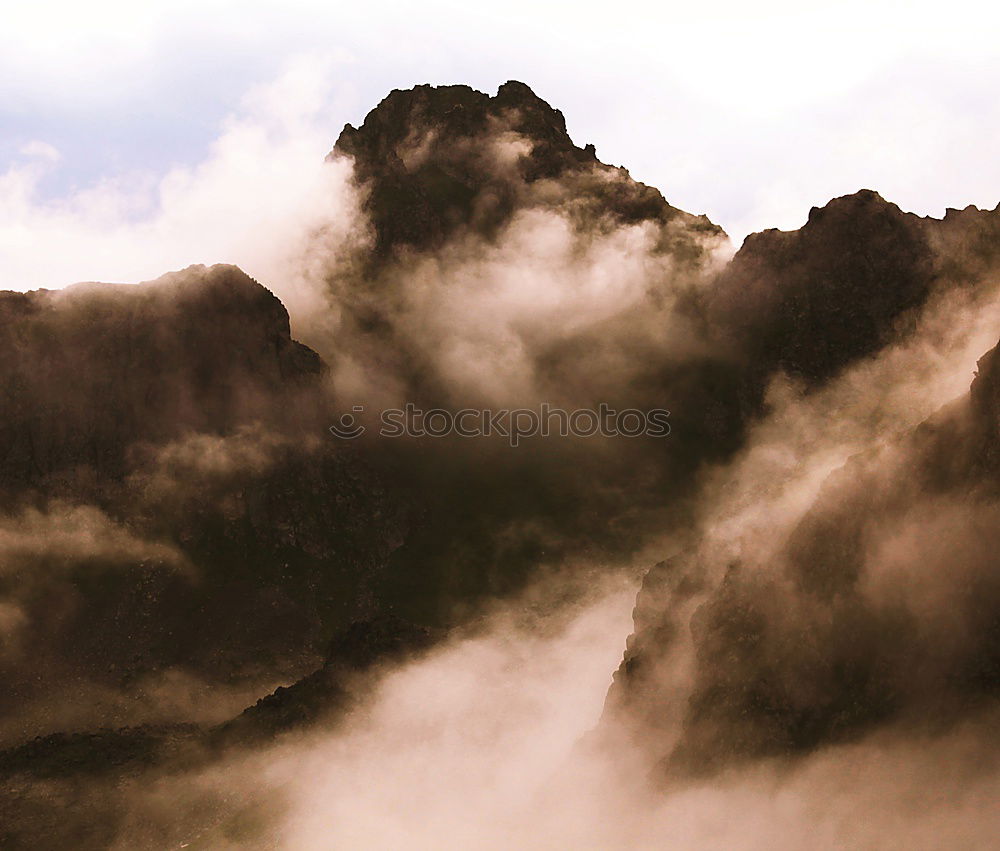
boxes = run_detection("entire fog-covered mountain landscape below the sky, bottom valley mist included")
[0,82,1000,847]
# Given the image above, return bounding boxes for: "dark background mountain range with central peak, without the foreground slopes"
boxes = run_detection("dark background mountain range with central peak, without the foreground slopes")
[0,82,1000,738]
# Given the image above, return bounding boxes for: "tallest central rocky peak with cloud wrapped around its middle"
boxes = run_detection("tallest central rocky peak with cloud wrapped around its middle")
[322,82,725,621]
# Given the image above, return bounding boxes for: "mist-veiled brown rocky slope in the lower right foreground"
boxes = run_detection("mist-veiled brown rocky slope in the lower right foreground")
[608,336,1000,773]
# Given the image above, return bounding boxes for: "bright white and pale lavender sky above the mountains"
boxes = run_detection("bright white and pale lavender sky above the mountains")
[0,0,1000,289]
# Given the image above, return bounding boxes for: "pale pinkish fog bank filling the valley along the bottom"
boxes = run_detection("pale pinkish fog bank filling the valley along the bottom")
[84,572,1000,851]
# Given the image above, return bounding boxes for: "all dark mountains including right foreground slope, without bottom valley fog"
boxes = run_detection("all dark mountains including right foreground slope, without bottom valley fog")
[0,81,1000,847]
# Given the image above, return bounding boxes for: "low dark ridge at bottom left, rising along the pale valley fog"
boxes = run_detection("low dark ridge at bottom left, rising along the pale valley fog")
[0,615,439,849]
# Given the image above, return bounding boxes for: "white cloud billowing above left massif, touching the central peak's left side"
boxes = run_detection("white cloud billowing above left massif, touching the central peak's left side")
[0,59,363,332]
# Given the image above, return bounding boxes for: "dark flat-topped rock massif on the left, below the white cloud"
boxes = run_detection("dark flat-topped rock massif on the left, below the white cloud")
[0,266,402,738]
